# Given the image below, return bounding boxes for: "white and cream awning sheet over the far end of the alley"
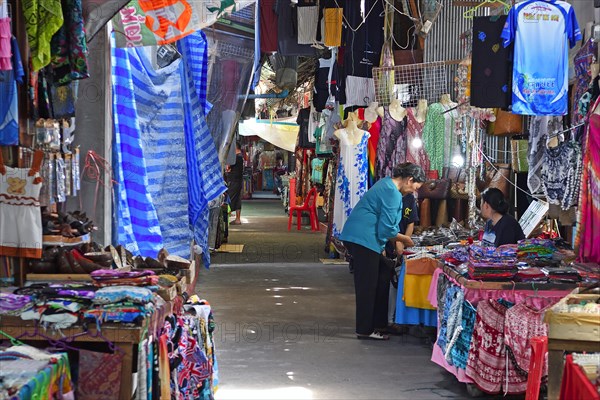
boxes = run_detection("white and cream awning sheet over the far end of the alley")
[239,119,300,152]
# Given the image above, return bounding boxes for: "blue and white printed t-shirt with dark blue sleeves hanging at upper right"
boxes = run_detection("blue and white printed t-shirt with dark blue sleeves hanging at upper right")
[502,0,581,115]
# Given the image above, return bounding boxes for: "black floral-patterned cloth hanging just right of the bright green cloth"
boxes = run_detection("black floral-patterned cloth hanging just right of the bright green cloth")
[50,0,90,85]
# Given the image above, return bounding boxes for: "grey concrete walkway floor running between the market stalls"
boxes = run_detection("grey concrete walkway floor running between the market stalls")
[198,200,468,400]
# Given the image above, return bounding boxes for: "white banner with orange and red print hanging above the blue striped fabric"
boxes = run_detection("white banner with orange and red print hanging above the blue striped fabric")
[112,0,255,47]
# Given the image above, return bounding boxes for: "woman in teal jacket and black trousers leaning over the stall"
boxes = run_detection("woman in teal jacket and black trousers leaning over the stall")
[340,163,425,340]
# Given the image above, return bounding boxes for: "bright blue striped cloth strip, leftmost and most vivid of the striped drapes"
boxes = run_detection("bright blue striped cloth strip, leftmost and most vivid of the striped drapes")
[112,46,163,256]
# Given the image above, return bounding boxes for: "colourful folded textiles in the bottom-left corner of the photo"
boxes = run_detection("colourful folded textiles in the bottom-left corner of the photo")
[0,342,74,400]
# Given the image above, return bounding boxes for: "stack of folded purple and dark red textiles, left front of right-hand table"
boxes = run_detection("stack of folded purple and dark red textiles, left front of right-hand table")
[468,245,518,281]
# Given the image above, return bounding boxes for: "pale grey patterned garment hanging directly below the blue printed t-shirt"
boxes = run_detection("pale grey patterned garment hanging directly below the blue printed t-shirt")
[527,117,562,193]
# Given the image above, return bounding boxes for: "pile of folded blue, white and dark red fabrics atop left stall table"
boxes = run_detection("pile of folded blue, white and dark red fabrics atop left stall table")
[83,270,159,323]
